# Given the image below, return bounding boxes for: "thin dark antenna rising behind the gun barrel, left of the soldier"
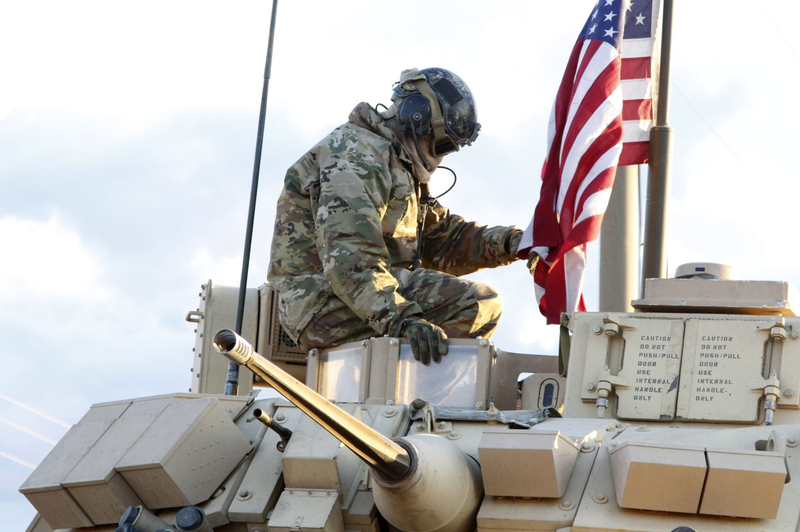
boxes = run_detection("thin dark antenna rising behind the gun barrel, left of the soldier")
[225,0,278,395]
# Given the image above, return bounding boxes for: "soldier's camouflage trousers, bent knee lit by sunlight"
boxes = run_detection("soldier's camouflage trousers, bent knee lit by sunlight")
[299,269,503,349]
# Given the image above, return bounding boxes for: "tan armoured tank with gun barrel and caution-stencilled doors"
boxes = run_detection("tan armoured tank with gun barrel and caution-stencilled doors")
[20,265,800,532]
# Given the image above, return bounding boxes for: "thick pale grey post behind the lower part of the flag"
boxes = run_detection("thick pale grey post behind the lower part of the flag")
[600,165,639,312]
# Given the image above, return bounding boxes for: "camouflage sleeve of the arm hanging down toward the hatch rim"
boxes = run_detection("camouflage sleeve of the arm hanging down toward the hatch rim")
[315,130,422,334]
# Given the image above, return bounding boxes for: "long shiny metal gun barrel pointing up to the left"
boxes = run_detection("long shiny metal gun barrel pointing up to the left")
[214,329,411,480]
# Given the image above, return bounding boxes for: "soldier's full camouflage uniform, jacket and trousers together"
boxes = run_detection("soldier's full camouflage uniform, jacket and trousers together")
[268,103,521,348]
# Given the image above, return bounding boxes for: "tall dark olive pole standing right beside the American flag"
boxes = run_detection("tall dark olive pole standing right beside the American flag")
[641,0,673,297]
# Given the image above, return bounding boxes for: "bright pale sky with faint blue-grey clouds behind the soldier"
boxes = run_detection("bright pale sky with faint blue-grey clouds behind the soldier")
[0,0,800,531]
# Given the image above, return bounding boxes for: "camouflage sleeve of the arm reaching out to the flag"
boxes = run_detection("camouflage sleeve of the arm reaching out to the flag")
[422,200,522,275]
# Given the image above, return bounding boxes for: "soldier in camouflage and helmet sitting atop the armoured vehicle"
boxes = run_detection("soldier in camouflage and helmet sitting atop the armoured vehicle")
[268,68,522,365]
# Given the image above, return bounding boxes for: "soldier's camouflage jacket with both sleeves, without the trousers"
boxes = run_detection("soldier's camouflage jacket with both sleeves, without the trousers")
[267,103,521,339]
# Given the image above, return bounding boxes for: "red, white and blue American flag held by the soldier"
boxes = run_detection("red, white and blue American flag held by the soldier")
[520,0,659,323]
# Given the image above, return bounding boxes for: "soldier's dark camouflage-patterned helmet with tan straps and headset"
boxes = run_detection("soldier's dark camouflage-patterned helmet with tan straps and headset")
[392,68,481,155]
